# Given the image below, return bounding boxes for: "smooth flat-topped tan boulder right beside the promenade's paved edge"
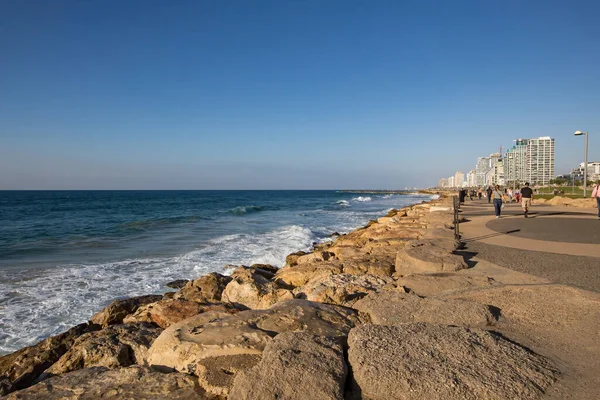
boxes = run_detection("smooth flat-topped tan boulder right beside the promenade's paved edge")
[396,239,467,277]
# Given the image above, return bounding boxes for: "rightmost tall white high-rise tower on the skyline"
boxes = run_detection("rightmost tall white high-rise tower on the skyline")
[525,136,554,185]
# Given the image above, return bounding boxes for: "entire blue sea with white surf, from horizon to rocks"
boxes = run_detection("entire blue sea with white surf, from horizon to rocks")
[0,191,430,354]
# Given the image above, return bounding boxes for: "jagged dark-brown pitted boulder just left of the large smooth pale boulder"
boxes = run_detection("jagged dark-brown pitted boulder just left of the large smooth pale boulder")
[42,323,162,378]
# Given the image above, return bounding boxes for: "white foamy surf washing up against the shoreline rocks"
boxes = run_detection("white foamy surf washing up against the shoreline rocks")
[0,225,317,354]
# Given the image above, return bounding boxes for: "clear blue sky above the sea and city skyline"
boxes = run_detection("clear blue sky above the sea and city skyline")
[0,0,600,189]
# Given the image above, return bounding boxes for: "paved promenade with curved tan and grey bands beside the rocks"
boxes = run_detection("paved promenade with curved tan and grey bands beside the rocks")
[460,199,600,291]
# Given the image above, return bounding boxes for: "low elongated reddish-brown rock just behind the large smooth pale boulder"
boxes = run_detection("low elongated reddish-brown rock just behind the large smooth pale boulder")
[123,299,239,329]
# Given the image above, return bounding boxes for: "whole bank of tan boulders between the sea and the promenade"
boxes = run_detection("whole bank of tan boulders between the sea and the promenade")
[0,195,576,399]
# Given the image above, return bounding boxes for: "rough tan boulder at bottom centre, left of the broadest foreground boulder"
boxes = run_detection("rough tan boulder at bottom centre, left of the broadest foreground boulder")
[228,332,347,400]
